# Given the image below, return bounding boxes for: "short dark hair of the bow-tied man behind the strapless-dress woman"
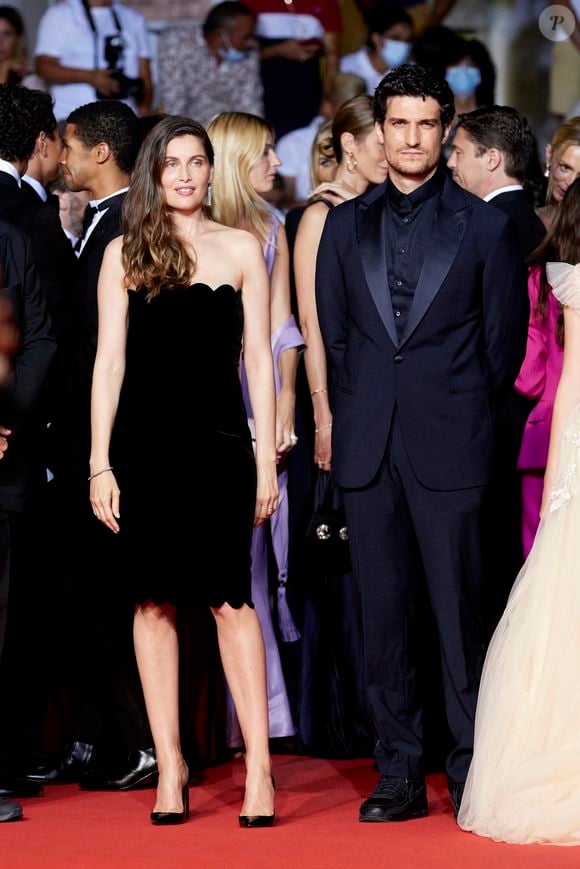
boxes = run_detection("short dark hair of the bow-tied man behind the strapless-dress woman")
[66,100,140,173]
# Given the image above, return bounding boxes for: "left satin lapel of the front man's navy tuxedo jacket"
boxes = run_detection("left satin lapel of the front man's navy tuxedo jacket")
[357,196,399,347]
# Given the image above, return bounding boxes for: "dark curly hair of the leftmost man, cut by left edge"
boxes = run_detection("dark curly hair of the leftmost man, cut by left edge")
[0,84,40,163]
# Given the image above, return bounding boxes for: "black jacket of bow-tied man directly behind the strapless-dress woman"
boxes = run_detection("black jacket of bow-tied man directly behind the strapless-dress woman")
[51,193,125,477]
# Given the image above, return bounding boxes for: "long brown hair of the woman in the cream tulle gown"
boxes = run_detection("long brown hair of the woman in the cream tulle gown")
[528,178,580,347]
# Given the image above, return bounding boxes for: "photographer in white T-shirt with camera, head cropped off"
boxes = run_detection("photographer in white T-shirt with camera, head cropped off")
[35,0,152,120]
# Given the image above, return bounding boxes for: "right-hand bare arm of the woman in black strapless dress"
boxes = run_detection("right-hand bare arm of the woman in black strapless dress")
[239,233,278,526]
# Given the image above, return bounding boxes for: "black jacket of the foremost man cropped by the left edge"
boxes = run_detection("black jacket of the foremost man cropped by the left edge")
[0,220,56,510]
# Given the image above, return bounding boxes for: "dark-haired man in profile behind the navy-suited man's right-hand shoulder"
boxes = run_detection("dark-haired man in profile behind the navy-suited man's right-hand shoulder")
[447,106,546,633]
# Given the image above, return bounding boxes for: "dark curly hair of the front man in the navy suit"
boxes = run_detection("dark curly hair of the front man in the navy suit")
[373,63,455,127]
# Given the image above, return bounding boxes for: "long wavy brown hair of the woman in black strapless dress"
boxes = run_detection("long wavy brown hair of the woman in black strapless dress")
[122,115,213,299]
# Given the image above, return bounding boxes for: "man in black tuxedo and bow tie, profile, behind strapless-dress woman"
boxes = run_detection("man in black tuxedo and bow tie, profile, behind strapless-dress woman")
[31,100,157,789]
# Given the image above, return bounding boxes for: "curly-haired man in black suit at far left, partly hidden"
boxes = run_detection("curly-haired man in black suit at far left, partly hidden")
[0,85,76,784]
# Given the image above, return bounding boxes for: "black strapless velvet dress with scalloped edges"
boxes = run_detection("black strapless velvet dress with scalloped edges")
[111,283,256,607]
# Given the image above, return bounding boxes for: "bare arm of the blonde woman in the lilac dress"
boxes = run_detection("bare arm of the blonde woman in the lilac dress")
[270,223,298,456]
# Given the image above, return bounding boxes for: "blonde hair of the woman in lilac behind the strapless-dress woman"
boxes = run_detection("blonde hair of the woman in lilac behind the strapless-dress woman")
[207,112,274,245]
